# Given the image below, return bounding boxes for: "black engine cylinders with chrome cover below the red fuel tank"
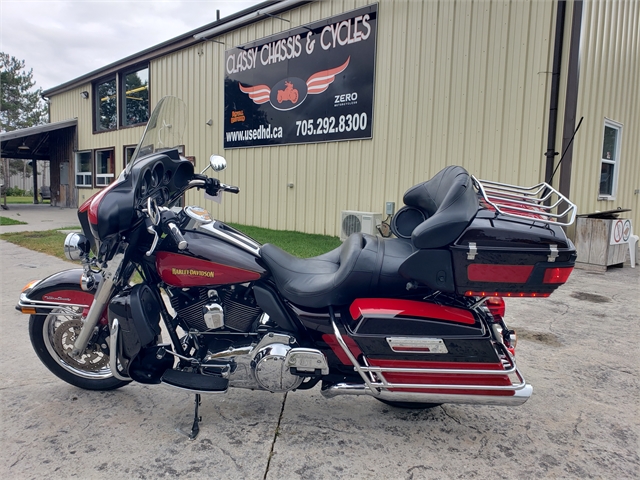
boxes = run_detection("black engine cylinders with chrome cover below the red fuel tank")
[168,285,262,333]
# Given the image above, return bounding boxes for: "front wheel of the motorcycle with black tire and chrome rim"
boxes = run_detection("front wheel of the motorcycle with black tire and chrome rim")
[29,307,129,390]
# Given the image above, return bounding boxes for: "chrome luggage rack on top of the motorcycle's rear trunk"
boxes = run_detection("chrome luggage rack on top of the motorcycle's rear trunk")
[471,175,577,226]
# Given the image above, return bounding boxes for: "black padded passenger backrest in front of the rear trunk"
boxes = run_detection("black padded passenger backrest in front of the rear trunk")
[403,166,478,248]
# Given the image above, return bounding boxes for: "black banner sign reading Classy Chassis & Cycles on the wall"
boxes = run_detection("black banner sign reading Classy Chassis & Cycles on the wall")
[224,5,378,148]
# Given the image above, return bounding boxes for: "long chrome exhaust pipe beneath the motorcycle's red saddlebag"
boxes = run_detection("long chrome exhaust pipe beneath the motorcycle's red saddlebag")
[320,383,533,407]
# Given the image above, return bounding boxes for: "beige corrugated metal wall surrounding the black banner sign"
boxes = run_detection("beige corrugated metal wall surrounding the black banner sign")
[152,0,555,235]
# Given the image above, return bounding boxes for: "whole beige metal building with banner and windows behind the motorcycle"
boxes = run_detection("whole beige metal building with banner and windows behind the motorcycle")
[3,0,640,240]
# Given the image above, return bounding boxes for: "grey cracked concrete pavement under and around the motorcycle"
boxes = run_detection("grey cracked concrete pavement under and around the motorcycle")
[0,232,640,480]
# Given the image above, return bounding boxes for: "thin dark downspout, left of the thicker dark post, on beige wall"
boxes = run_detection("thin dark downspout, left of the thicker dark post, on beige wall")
[544,0,567,183]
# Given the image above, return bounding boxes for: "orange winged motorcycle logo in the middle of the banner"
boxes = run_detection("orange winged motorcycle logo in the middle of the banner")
[239,57,351,111]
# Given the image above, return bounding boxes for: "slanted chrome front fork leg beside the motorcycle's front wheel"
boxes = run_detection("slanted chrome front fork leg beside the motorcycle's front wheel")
[71,253,124,357]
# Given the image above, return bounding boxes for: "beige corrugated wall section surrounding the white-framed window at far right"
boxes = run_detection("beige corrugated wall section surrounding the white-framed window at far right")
[571,0,640,233]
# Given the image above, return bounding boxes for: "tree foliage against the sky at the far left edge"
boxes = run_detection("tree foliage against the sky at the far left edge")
[0,52,47,132]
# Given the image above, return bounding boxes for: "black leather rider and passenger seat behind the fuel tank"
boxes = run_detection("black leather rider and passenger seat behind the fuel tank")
[261,233,413,308]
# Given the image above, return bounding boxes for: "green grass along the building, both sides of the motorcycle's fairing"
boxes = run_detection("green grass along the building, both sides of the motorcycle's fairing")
[0,223,340,260]
